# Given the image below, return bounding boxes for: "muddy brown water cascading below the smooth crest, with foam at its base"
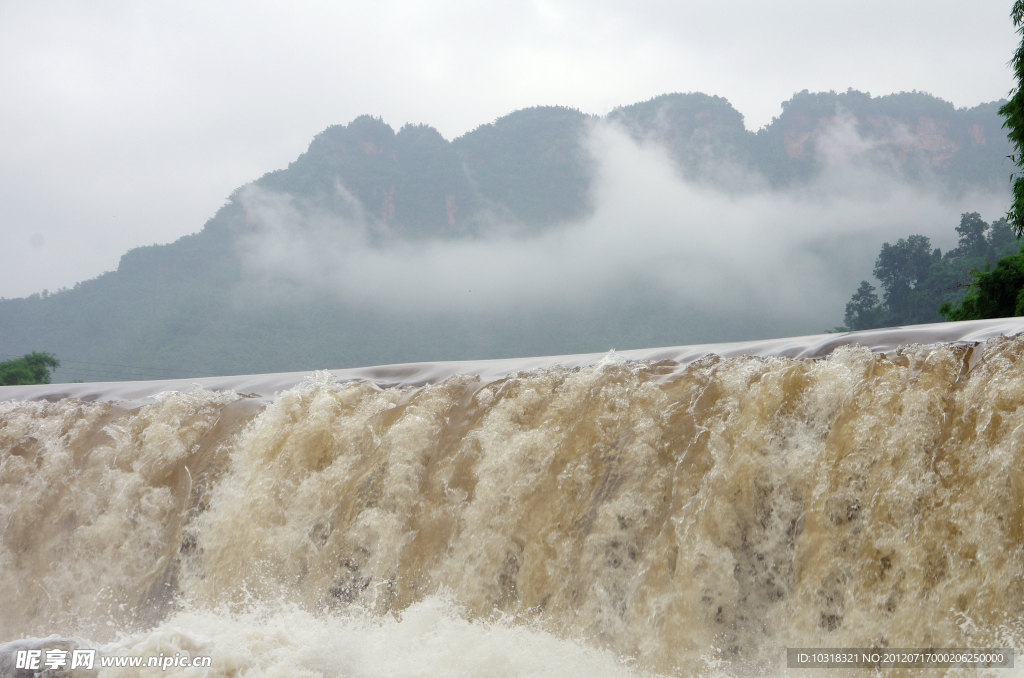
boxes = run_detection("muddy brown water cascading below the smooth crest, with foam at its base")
[6,338,1024,676]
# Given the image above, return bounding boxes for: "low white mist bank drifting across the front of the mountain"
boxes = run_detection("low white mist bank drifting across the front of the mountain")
[232,116,1007,332]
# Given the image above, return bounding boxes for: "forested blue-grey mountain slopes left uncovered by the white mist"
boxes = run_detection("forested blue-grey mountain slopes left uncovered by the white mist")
[0,90,1012,381]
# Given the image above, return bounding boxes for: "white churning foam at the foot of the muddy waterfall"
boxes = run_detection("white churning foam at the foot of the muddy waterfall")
[0,594,650,678]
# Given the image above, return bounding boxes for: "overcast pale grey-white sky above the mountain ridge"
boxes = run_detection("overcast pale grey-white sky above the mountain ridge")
[0,0,1017,297]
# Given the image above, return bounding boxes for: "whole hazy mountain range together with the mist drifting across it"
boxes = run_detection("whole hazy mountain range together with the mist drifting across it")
[0,90,1012,380]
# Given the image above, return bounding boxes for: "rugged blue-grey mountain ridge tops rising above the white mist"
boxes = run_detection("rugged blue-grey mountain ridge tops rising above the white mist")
[214,90,1012,241]
